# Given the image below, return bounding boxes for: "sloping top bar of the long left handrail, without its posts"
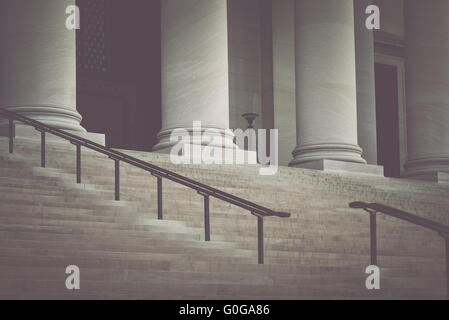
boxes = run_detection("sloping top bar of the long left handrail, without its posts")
[0,109,290,218]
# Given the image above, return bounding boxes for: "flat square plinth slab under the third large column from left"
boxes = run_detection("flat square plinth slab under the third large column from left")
[295,159,384,177]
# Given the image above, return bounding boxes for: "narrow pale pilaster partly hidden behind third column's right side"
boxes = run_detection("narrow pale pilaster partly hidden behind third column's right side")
[354,0,377,165]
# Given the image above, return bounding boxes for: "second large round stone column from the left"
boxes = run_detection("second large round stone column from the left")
[154,0,233,152]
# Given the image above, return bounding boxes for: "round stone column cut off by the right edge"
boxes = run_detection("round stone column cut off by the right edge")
[404,0,449,180]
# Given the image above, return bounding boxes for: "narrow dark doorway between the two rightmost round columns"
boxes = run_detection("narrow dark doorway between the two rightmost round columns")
[376,63,401,177]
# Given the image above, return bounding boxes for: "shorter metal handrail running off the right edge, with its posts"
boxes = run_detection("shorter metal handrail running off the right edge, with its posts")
[349,201,449,299]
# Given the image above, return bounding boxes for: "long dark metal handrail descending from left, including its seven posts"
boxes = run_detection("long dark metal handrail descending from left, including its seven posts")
[0,108,290,264]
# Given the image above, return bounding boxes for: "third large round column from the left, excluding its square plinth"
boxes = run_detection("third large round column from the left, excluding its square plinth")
[290,0,366,167]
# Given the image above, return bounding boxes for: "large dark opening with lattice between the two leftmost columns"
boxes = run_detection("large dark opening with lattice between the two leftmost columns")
[77,0,161,151]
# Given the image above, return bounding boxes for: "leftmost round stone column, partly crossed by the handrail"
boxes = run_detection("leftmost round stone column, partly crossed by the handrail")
[0,0,85,132]
